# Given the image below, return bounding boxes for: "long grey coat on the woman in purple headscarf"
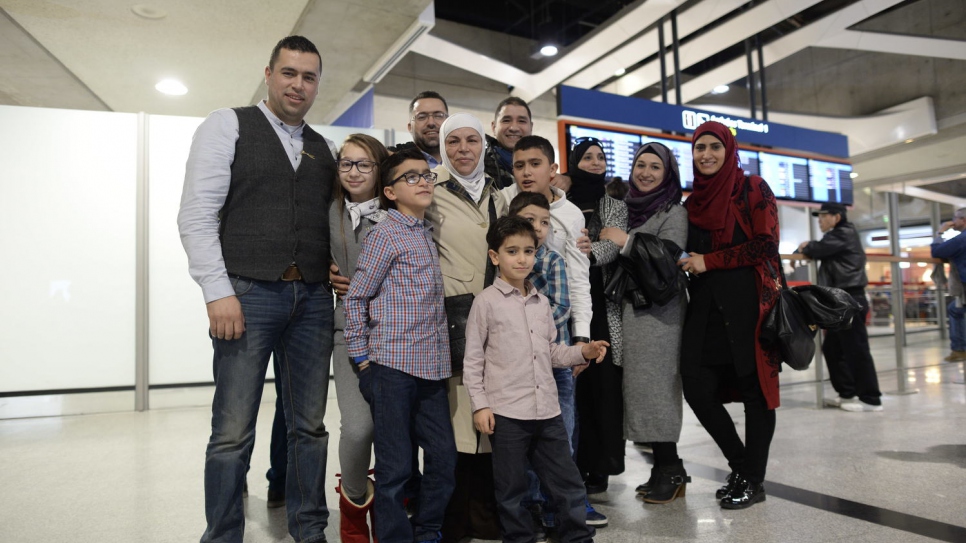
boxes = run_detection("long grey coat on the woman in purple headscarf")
[621,205,688,442]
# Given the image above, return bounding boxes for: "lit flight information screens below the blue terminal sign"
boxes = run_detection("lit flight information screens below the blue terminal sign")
[565,124,852,205]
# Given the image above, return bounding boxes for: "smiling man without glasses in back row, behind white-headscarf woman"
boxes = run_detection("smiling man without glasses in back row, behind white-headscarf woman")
[483,96,533,189]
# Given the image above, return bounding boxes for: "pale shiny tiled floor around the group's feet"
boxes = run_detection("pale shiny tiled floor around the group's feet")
[0,333,966,543]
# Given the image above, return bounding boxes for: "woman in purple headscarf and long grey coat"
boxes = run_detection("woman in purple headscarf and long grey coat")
[600,142,690,503]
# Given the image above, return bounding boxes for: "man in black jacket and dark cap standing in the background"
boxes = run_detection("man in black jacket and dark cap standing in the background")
[798,203,882,412]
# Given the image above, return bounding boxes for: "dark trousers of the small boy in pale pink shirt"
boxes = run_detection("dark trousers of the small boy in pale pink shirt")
[490,415,594,543]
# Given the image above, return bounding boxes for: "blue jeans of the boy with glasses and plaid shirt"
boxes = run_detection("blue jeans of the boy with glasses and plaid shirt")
[359,363,456,543]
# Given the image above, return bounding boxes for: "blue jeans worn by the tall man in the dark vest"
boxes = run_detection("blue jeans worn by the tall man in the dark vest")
[201,277,332,543]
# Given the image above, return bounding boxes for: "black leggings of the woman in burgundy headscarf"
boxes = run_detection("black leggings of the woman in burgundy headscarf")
[681,366,775,483]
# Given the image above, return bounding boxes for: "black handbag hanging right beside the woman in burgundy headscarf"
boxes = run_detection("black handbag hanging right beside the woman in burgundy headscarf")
[760,263,818,371]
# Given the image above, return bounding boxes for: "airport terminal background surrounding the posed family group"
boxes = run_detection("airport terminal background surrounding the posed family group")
[0,0,966,543]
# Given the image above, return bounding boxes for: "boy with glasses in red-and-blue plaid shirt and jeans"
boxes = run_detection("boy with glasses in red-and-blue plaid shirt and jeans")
[345,149,456,542]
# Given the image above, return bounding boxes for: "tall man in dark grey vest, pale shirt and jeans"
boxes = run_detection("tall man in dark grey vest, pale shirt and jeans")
[178,36,336,543]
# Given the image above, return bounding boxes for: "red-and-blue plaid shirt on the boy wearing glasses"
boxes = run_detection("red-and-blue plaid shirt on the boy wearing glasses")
[345,209,452,381]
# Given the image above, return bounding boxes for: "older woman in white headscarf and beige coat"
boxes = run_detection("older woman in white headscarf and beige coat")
[426,113,507,541]
